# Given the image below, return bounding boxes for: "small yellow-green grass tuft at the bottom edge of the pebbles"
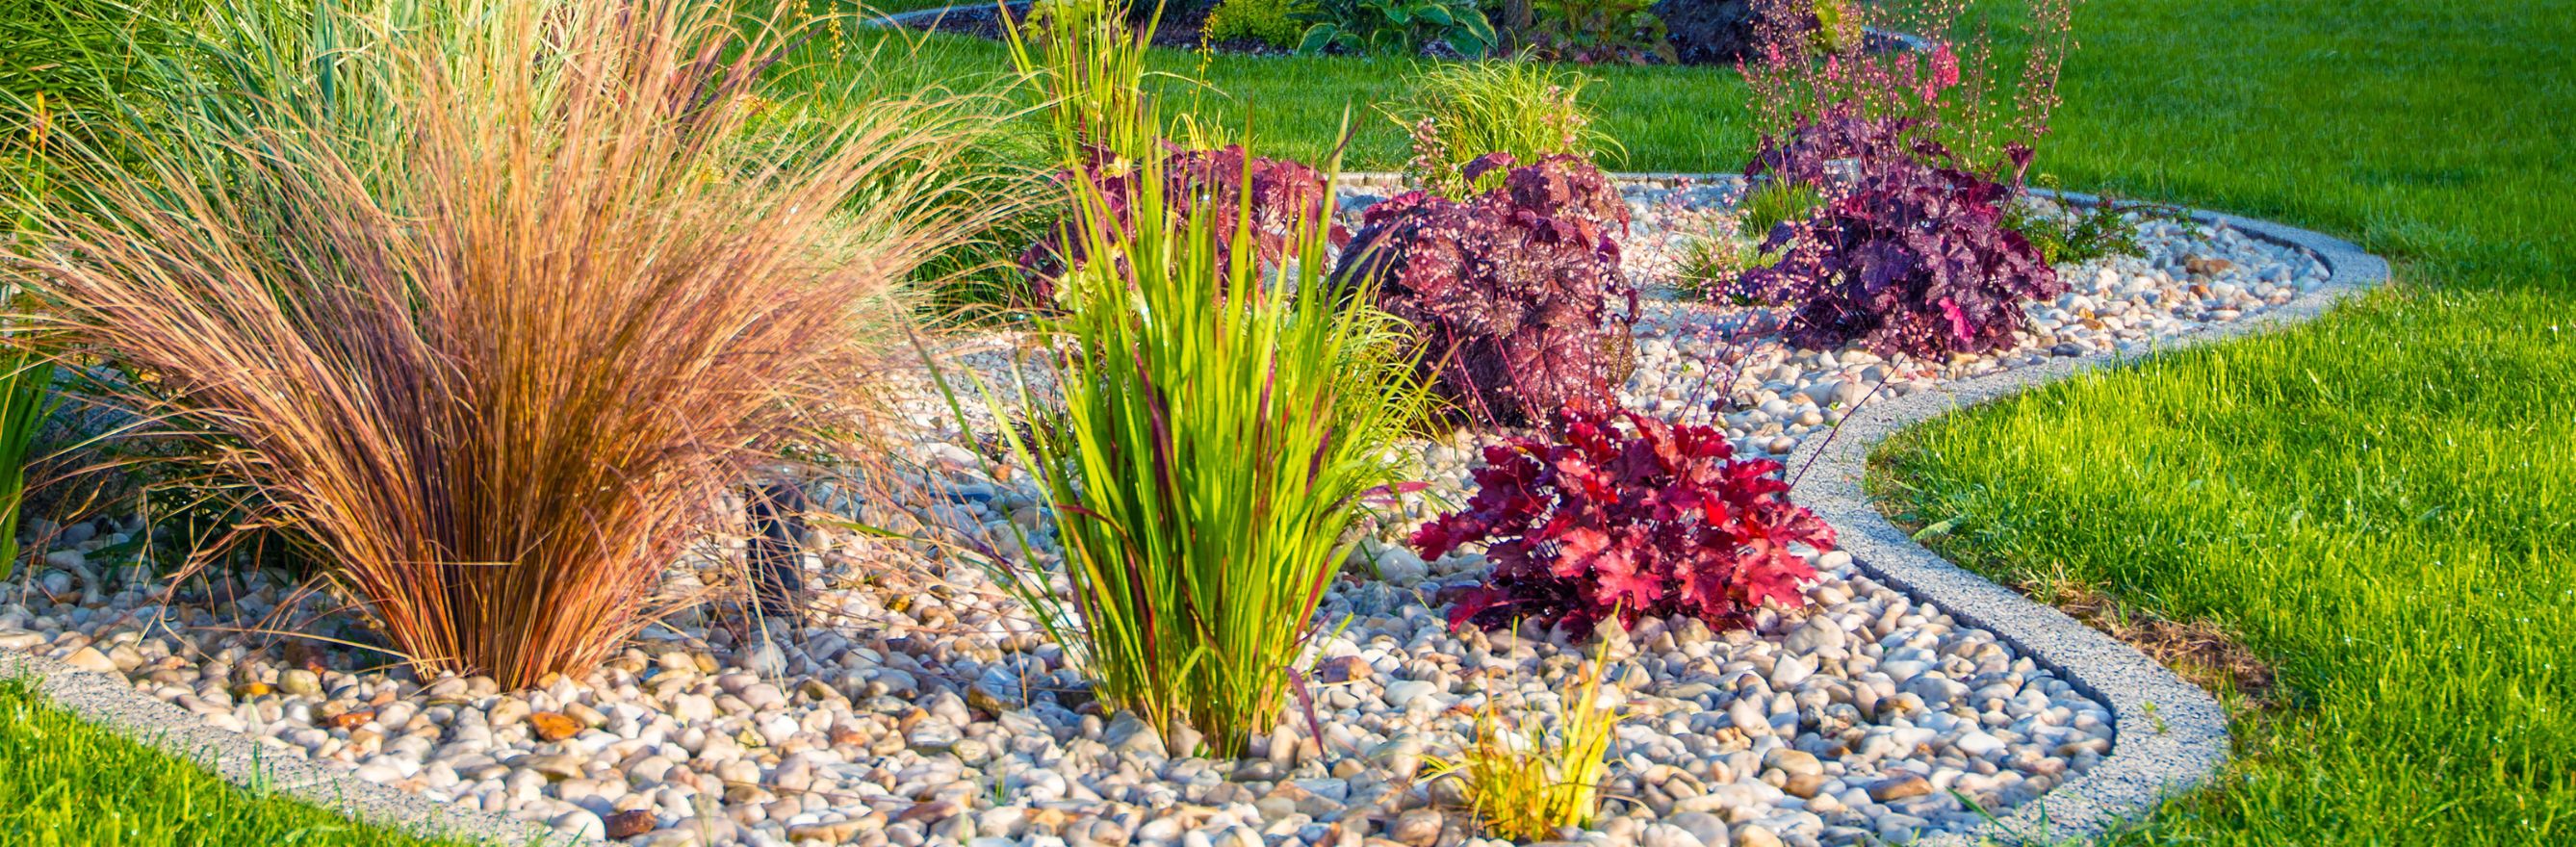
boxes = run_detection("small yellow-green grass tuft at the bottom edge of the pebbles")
[1425,641,1623,842]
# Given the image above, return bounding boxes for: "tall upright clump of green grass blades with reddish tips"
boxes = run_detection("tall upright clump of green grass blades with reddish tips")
[950,8,1430,752]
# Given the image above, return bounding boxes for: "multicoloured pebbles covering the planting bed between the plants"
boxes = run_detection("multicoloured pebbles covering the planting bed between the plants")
[0,180,2326,847]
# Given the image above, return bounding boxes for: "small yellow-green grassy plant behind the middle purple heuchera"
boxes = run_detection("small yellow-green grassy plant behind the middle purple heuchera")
[1386,60,1620,201]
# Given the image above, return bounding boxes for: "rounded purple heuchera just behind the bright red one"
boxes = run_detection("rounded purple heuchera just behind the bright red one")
[1334,152,1636,427]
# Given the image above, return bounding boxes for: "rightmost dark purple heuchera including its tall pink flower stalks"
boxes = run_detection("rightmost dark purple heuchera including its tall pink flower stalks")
[1734,0,2074,358]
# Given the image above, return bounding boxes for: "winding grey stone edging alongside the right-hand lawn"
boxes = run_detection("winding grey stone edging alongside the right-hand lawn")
[1788,193,2388,844]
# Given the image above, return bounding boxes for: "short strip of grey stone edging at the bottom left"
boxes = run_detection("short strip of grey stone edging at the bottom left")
[0,649,575,844]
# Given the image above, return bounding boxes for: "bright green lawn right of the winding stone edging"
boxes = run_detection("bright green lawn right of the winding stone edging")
[1880,0,2576,844]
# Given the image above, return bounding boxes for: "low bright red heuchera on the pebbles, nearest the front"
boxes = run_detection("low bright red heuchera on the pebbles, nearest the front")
[1414,412,1834,630]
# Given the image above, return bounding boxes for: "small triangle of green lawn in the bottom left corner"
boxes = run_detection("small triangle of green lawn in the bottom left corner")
[0,680,474,847]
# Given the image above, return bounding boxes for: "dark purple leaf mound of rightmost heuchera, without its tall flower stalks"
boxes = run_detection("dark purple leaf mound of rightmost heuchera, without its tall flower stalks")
[1737,114,2066,358]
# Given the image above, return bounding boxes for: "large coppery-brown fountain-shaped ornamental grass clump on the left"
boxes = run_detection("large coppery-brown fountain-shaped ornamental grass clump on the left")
[8,0,982,684]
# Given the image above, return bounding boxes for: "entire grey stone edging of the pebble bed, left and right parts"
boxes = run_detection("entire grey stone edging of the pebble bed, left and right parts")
[0,172,2388,847]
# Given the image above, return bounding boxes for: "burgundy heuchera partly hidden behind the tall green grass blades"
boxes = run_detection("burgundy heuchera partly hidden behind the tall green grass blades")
[1020,141,1350,301]
